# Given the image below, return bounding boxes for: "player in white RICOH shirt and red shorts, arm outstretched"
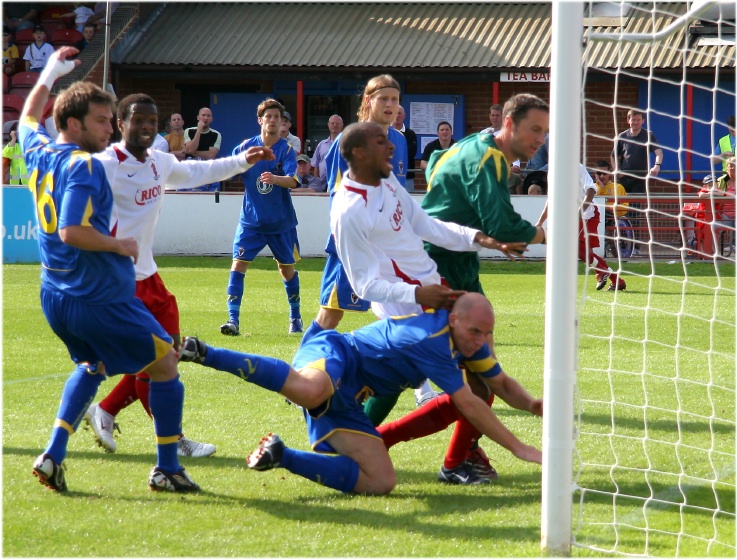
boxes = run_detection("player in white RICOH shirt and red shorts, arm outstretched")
[85,94,273,457]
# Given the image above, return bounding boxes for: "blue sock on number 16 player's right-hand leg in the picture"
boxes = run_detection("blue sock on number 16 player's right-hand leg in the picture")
[149,375,184,473]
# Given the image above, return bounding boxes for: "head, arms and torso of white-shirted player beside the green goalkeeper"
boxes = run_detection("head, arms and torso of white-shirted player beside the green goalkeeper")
[330,122,525,319]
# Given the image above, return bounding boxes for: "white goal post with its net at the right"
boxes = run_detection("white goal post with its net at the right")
[541,1,737,557]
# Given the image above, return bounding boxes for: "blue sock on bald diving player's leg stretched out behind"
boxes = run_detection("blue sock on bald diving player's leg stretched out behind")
[206,345,292,394]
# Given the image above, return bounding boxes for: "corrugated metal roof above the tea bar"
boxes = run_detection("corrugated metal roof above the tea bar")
[114,1,735,70]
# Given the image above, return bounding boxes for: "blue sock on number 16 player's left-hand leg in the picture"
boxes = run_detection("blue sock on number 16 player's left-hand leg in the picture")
[45,364,106,464]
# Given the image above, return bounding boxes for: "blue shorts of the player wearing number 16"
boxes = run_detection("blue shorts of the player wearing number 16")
[41,287,172,375]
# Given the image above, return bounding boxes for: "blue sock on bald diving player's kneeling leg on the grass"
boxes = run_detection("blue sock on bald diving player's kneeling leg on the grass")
[279,447,359,492]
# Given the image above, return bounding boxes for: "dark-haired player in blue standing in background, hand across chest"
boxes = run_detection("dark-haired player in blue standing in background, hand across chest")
[220,99,302,336]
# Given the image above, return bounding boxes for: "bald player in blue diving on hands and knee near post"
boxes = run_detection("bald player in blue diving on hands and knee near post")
[180,293,543,494]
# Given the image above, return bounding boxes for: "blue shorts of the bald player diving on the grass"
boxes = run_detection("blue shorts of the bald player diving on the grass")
[292,330,381,453]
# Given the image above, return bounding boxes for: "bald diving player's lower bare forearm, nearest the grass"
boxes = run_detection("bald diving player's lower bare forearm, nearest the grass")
[450,385,542,463]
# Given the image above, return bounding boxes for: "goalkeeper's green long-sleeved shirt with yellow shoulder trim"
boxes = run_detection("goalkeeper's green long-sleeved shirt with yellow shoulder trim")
[422,133,537,254]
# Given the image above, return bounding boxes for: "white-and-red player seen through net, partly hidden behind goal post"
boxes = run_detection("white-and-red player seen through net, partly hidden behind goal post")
[535,163,627,292]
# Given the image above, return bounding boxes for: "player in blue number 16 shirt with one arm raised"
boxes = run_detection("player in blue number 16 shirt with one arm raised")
[20,47,200,492]
